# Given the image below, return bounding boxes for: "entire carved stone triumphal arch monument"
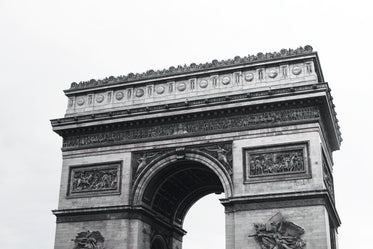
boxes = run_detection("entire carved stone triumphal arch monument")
[51,46,342,249]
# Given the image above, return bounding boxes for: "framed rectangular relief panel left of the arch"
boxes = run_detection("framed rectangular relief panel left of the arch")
[68,162,121,197]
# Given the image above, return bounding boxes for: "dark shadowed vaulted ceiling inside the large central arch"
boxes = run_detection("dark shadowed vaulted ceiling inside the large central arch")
[143,161,224,225]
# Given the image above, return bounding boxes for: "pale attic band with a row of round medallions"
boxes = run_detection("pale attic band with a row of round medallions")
[67,61,318,113]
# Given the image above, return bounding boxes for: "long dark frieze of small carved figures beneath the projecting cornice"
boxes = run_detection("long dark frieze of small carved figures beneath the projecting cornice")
[63,107,320,149]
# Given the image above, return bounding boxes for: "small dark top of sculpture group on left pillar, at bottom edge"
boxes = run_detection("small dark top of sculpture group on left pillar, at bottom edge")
[72,231,105,249]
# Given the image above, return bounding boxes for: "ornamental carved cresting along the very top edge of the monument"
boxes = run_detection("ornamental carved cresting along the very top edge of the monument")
[69,45,313,90]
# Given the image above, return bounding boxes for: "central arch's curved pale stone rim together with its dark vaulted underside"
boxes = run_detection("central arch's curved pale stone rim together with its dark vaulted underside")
[131,149,233,226]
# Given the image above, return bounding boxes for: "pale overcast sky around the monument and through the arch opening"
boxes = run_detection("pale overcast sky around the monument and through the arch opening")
[0,0,373,249]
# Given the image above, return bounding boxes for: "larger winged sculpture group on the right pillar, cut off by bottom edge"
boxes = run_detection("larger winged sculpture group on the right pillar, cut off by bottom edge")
[249,213,306,249]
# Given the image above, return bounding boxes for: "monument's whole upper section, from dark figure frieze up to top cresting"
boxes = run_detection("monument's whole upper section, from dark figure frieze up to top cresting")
[51,46,342,150]
